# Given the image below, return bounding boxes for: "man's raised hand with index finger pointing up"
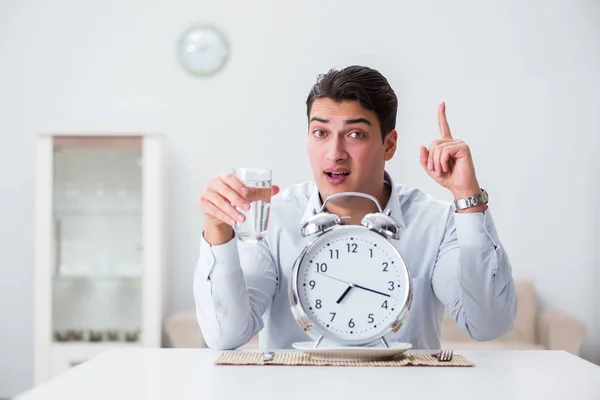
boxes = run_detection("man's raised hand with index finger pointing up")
[420,102,481,199]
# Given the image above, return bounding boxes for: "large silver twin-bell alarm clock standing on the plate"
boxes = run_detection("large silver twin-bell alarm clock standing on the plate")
[289,192,413,348]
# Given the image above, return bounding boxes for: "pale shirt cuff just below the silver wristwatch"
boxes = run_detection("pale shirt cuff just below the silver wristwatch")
[454,209,500,249]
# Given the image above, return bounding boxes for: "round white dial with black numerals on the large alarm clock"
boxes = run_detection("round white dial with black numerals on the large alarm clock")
[297,226,409,343]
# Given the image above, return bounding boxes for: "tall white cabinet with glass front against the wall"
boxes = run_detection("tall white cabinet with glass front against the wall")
[34,135,166,384]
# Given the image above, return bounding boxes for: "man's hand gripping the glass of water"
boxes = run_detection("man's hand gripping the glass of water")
[198,173,279,246]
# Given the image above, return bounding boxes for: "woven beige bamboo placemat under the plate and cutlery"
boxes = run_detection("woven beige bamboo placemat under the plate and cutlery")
[215,351,475,367]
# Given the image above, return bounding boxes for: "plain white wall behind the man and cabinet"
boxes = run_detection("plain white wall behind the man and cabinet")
[0,0,600,397]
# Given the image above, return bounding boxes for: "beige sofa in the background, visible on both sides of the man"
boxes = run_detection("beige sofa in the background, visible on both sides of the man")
[165,281,586,355]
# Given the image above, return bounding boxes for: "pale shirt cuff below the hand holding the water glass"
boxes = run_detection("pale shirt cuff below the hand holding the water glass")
[200,231,240,280]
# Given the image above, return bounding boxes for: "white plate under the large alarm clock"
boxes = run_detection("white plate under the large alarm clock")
[292,342,412,361]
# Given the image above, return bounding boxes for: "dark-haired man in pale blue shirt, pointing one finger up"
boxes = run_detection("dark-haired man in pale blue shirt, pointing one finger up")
[194,66,517,349]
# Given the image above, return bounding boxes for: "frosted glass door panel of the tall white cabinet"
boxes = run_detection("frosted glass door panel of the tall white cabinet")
[52,136,143,342]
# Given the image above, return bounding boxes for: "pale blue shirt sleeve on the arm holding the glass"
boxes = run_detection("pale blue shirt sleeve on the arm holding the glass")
[194,234,278,349]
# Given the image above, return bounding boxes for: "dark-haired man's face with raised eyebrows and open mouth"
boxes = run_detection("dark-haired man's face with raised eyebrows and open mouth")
[308,98,397,204]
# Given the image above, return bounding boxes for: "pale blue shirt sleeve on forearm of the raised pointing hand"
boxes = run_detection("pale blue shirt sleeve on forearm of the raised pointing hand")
[432,209,517,341]
